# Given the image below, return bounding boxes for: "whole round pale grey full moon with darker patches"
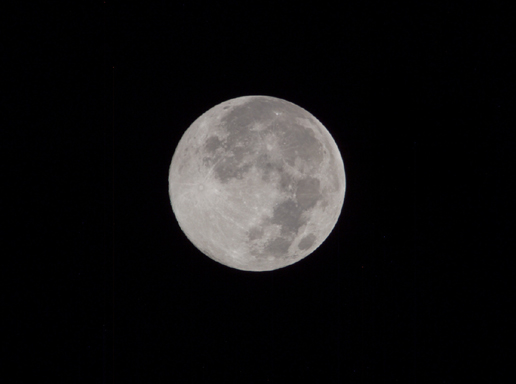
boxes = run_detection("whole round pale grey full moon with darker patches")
[169,96,346,271]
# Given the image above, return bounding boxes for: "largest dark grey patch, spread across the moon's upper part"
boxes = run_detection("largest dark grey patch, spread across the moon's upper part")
[204,98,324,188]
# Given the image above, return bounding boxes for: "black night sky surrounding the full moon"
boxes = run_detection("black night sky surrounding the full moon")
[0,1,516,383]
